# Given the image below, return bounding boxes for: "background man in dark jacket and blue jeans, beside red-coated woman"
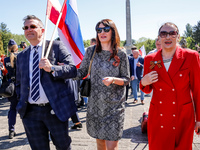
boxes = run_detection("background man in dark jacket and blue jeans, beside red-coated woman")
[129,46,144,105]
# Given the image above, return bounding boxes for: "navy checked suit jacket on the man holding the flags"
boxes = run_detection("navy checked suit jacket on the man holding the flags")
[16,41,77,121]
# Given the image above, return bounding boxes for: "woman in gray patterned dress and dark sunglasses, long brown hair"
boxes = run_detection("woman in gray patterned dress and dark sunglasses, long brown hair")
[77,19,130,150]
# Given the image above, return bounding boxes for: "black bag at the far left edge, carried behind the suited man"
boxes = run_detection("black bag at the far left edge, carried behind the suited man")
[0,81,15,97]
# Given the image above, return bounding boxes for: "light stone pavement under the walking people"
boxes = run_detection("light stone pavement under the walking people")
[0,93,200,150]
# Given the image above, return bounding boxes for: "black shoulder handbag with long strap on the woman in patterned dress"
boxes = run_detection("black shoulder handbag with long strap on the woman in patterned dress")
[80,46,96,97]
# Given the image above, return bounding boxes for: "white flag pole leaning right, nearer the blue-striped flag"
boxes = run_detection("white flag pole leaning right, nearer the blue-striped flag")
[45,0,67,58]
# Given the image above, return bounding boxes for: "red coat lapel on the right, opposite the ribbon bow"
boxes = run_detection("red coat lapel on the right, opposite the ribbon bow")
[168,47,185,79]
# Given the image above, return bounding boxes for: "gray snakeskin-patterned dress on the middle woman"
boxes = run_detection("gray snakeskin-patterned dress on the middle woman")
[77,46,130,141]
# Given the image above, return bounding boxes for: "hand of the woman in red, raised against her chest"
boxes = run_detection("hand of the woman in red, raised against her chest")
[141,71,158,86]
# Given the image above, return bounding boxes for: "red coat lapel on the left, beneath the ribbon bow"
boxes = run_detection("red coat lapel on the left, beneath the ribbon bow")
[153,50,173,87]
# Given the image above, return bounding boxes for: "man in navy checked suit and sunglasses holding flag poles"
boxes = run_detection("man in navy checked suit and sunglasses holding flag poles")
[16,15,77,150]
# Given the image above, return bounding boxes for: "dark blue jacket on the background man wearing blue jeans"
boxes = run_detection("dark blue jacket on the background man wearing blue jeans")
[129,56,144,81]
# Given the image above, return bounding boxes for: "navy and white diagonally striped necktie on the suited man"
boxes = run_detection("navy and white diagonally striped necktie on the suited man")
[31,46,40,102]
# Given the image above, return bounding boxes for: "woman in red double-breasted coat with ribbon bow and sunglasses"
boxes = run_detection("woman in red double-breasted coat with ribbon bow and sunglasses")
[140,22,200,150]
